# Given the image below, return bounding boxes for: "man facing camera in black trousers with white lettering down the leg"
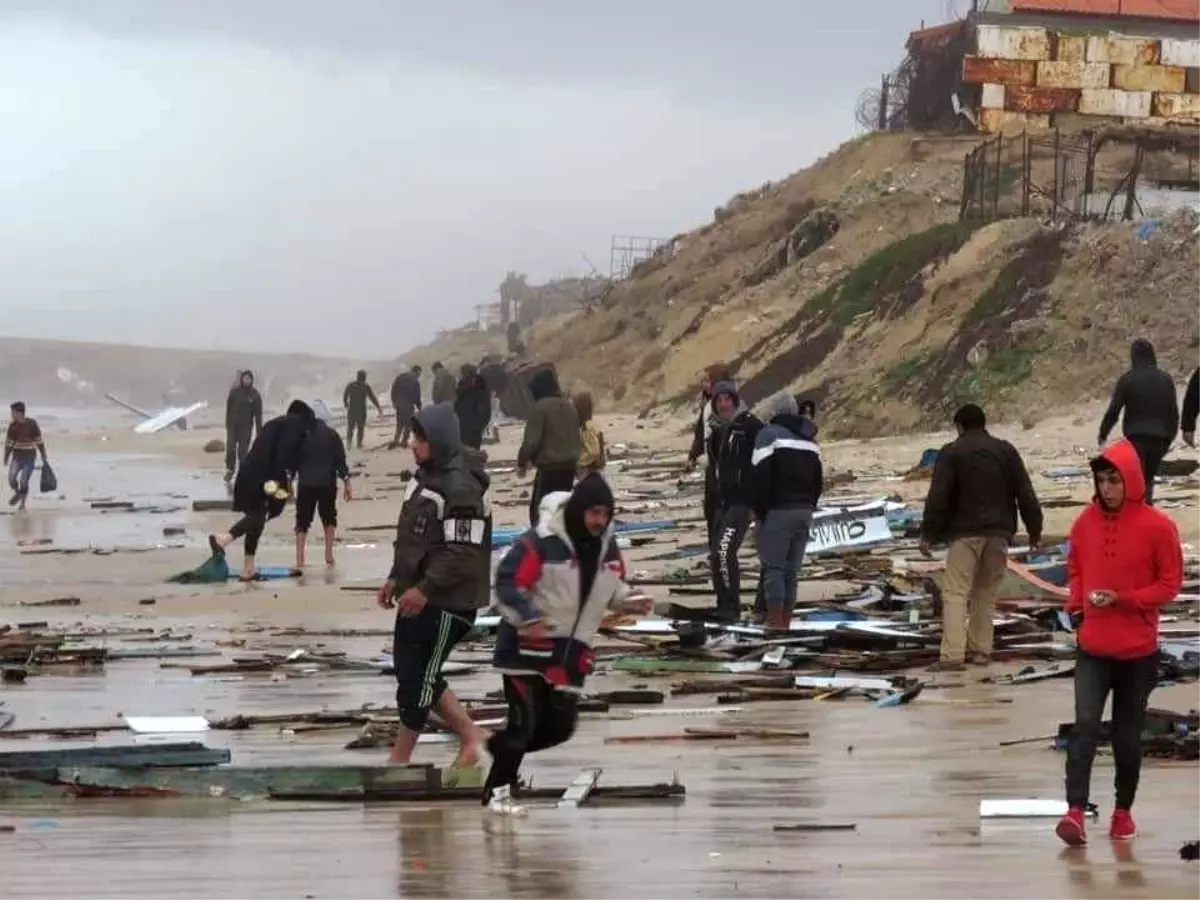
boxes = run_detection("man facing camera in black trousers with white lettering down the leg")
[708,382,762,622]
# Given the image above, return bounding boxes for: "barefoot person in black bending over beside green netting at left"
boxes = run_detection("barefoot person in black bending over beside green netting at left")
[209,400,317,581]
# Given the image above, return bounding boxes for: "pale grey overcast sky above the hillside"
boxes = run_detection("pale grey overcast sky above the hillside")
[0,0,948,358]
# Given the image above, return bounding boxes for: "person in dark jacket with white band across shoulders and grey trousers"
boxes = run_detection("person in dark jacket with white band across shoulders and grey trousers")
[751,394,824,631]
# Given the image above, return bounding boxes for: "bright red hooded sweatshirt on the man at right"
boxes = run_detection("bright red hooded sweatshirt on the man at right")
[1067,440,1183,659]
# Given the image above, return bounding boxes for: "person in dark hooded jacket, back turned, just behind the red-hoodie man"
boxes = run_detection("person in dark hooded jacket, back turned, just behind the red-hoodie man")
[1099,337,1176,504]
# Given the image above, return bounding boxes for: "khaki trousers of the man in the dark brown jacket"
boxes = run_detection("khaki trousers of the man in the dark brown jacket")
[942,538,1008,662]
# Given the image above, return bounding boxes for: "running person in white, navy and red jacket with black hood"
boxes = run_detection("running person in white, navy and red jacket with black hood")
[484,474,652,815]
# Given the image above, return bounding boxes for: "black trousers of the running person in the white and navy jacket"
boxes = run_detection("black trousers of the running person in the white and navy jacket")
[484,674,578,806]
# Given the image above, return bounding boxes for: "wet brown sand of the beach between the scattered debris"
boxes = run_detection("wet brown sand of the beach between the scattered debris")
[7,405,1200,900]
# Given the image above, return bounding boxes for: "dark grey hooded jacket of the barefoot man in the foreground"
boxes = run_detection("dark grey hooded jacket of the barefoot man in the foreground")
[388,403,492,613]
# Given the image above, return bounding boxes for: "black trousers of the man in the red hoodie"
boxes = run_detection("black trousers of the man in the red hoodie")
[1067,652,1158,809]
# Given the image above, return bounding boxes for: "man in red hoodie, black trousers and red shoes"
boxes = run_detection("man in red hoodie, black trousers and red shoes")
[1056,440,1183,846]
